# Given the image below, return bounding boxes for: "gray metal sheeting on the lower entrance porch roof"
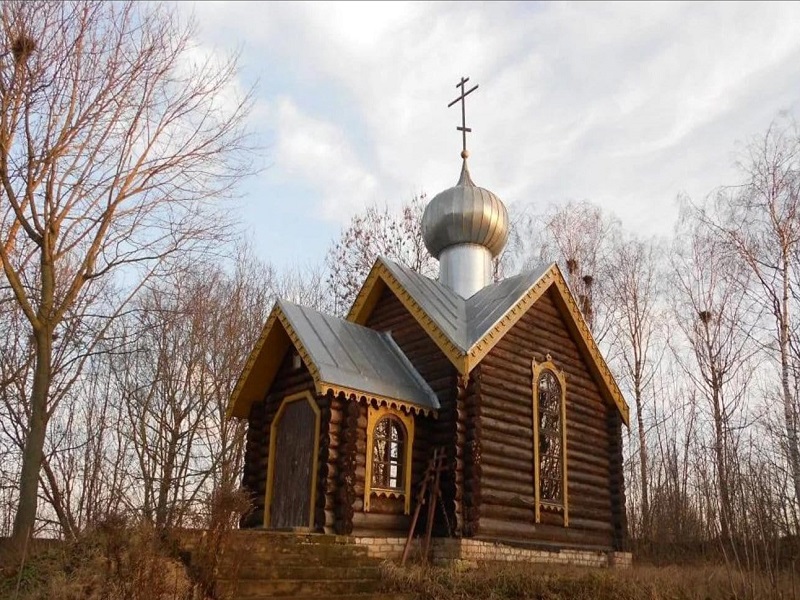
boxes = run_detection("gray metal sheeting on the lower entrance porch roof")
[278,300,439,410]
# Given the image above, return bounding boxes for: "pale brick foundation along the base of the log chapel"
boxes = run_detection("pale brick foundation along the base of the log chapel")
[353,537,631,569]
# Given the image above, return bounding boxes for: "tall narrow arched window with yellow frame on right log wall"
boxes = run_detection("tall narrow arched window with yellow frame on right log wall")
[533,354,569,527]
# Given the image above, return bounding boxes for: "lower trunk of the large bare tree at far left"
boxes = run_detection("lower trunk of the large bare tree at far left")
[12,329,53,544]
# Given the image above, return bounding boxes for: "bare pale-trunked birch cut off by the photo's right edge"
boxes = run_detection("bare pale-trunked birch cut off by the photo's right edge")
[699,120,800,502]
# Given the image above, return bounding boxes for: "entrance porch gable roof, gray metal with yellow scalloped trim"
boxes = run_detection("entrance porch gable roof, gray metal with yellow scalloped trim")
[228,300,439,417]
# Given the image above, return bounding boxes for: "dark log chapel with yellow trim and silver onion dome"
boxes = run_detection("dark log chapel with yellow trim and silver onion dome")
[229,80,629,564]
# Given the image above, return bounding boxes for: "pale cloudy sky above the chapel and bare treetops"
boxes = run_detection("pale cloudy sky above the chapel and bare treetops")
[180,1,800,267]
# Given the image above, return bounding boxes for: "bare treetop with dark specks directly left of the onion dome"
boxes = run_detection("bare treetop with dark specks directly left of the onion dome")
[325,196,439,314]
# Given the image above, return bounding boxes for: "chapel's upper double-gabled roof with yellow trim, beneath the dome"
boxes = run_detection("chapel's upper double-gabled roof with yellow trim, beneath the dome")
[347,257,630,425]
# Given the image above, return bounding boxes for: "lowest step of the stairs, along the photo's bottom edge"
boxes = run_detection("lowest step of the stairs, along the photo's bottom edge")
[216,579,380,600]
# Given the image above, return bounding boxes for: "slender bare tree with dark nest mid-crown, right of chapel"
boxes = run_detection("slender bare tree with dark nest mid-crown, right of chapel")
[671,207,759,541]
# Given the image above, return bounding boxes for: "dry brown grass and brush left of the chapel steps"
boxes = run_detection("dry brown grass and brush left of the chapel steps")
[0,489,250,600]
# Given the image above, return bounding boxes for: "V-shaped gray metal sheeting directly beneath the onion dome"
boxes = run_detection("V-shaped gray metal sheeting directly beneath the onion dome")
[380,257,552,353]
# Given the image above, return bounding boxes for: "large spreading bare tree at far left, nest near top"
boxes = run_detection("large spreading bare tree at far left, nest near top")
[0,1,249,541]
